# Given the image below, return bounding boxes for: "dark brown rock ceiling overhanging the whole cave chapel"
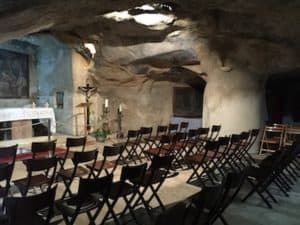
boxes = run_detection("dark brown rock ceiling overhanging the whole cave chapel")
[0,0,300,85]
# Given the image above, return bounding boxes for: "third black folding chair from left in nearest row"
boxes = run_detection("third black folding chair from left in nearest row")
[101,163,147,225]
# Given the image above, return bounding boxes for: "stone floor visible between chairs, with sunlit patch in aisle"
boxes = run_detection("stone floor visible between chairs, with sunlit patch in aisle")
[0,136,300,225]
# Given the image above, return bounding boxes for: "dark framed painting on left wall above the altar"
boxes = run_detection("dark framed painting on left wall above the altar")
[0,49,29,98]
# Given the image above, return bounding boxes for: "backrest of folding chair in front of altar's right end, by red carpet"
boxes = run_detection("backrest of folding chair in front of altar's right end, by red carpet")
[31,140,56,158]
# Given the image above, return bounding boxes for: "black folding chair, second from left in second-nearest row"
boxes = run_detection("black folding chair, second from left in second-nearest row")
[13,156,57,196]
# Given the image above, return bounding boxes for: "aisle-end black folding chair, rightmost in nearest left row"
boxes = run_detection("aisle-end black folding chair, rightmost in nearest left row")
[133,155,174,218]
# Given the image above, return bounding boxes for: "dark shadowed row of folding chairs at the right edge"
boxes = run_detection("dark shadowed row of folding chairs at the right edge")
[243,138,300,208]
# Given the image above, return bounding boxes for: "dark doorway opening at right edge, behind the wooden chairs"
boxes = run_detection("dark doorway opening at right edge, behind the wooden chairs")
[266,71,300,124]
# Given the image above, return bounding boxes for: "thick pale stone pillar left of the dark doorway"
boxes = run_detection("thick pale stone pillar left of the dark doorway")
[203,67,266,135]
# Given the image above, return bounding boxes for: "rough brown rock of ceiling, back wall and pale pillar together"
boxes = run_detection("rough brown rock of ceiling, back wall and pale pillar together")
[0,0,300,137]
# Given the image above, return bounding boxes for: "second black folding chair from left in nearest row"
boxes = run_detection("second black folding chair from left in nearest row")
[56,174,113,225]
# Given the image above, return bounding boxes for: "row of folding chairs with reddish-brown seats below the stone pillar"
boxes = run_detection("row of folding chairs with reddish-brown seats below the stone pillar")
[184,129,259,186]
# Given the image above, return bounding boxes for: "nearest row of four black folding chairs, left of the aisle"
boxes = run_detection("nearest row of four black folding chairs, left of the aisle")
[0,156,173,225]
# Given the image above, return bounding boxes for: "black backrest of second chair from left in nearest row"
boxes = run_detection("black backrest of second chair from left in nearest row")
[76,174,113,204]
